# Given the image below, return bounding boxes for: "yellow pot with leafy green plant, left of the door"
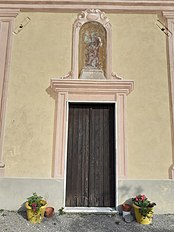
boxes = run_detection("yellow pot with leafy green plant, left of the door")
[25,193,47,224]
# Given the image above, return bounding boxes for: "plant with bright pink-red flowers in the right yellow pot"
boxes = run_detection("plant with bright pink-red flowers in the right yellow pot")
[132,194,156,217]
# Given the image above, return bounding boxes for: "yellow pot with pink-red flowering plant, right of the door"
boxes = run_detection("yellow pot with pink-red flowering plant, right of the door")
[132,194,156,225]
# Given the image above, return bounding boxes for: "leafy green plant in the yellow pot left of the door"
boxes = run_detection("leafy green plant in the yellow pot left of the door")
[27,193,46,213]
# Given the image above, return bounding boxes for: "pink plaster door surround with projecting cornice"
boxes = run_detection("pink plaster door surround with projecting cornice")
[51,79,134,178]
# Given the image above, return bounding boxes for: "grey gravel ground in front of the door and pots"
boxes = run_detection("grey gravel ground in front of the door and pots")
[0,211,174,232]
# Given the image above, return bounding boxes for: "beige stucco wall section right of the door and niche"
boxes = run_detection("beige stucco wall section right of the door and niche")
[111,14,172,179]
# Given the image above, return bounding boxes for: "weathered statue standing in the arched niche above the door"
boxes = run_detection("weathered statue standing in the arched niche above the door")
[84,32,102,69]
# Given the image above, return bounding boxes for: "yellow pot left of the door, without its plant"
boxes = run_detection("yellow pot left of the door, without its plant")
[25,201,47,224]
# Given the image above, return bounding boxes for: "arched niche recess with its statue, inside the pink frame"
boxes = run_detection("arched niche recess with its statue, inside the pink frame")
[79,21,107,78]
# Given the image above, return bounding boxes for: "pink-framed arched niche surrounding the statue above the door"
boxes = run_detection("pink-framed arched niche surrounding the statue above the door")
[71,9,113,79]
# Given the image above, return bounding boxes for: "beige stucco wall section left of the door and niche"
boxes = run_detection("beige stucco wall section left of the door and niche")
[4,13,75,177]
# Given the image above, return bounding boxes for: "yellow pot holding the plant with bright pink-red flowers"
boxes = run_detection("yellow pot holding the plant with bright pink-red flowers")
[133,204,153,225]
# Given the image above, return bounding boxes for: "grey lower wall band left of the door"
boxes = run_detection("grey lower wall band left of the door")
[0,178,64,211]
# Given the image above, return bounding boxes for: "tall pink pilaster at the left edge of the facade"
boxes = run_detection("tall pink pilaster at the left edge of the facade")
[0,9,19,176]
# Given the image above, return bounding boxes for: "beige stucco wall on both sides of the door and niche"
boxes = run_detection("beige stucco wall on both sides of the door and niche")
[4,13,172,179]
